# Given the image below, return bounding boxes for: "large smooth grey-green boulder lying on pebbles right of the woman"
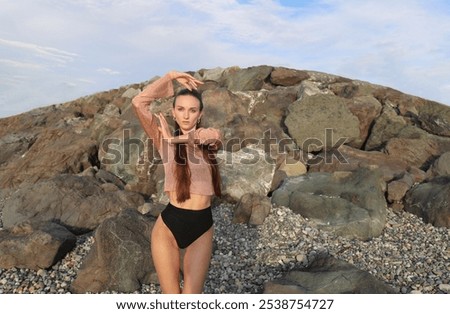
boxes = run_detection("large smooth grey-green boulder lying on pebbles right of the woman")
[272,169,387,240]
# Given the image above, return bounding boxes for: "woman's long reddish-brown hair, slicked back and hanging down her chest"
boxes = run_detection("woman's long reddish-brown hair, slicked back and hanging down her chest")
[173,89,222,203]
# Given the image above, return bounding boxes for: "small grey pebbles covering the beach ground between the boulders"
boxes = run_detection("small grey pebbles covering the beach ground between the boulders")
[0,203,450,294]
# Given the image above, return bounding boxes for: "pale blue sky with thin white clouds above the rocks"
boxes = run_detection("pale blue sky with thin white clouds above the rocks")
[0,0,450,118]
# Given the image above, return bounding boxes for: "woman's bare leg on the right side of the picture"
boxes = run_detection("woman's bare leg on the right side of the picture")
[183,227,214,293]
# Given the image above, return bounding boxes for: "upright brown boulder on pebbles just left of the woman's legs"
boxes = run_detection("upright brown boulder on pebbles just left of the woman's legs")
[71,209,157,293]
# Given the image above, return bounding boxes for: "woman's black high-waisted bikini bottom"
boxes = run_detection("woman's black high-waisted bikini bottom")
[161,203,213,249]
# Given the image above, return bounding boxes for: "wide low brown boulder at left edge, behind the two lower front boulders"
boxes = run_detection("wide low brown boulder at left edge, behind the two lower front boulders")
[3,174,144,234]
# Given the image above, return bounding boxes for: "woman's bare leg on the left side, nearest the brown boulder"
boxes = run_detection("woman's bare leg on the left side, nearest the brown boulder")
[151,216,181,294]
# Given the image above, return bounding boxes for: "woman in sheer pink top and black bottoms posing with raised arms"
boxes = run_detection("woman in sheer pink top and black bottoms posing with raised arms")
[133,71,220,293]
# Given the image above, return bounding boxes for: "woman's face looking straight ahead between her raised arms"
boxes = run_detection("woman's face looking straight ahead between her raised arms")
[172,95,203,133]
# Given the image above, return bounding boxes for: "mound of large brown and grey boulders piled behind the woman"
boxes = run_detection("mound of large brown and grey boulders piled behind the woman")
[0,66,450,293]
